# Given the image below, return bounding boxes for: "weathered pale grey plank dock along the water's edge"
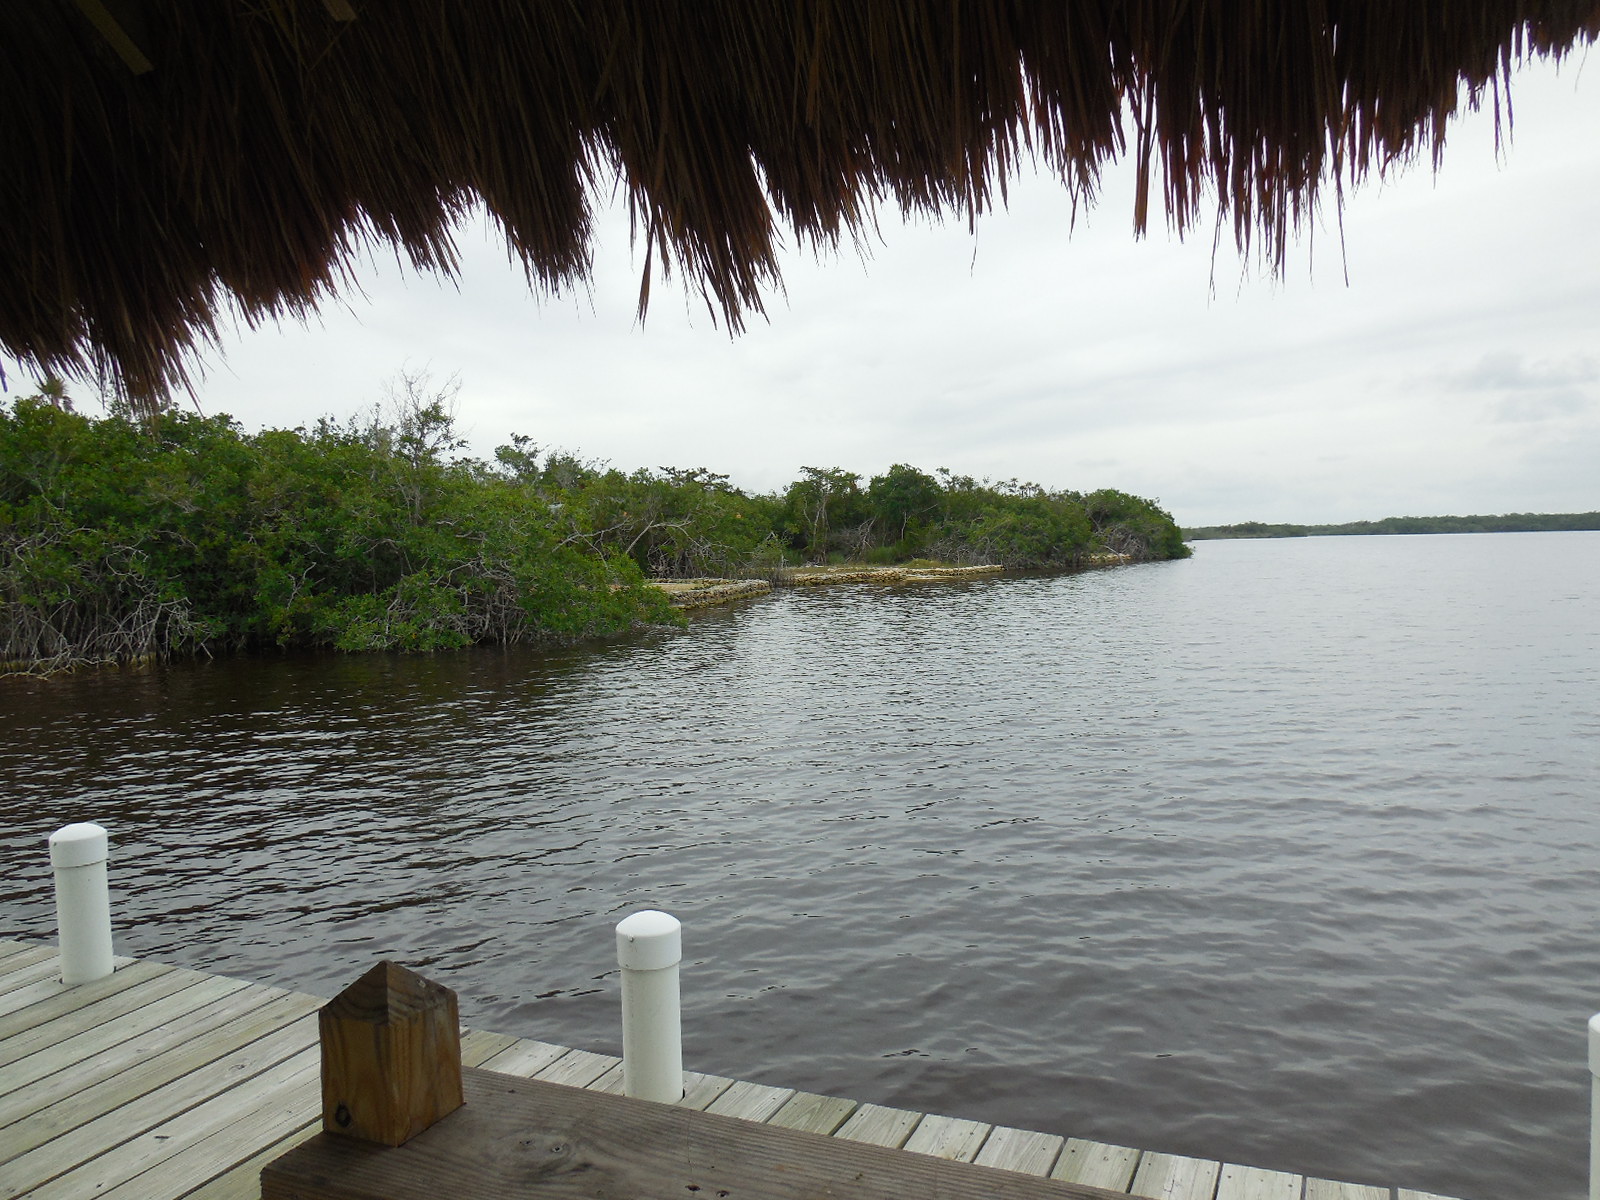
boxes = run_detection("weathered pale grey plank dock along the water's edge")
[0,941,1465,1200]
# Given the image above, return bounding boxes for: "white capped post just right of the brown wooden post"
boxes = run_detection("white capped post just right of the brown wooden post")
[616,909,683,1104]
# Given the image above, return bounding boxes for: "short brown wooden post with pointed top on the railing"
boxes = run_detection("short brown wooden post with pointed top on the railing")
[317,962,464,1146]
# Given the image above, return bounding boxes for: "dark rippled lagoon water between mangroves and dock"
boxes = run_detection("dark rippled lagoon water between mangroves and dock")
[0,533,1600,1200]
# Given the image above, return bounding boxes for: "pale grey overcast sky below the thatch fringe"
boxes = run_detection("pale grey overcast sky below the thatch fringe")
[13,59,1600,525]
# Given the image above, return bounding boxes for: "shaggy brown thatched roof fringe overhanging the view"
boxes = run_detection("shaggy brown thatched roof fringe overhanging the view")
[0,0,1600,403]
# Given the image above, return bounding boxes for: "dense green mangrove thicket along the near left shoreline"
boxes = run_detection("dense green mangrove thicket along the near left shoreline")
[0,379,1187,669]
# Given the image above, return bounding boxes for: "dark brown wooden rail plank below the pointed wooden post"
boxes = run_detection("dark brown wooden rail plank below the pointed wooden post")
[262,1070,1139,1200]
